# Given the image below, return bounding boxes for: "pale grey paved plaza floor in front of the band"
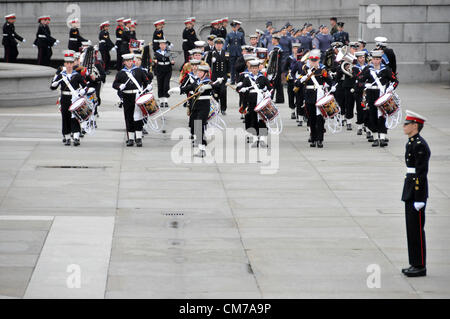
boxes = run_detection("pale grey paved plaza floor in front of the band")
[0,75,450,298]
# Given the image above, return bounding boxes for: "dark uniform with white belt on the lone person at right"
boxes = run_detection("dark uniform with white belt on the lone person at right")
[402,134,431,267]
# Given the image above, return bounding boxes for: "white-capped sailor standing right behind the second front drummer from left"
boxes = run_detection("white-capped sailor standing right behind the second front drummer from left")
[155,39,175,107]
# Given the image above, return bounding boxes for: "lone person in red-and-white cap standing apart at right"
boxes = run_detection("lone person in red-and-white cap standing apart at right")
[402,110,431,277]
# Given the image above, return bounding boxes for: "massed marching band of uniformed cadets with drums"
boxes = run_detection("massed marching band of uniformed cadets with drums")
[3,14,401,153]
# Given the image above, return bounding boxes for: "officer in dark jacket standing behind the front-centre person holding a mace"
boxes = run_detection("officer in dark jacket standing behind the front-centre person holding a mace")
[206,38,230,115]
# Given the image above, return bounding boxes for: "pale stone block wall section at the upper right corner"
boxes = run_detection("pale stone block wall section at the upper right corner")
[359,0,450,83]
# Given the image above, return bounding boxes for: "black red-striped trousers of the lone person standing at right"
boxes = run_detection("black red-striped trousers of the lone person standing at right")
[405,201,426,267]
